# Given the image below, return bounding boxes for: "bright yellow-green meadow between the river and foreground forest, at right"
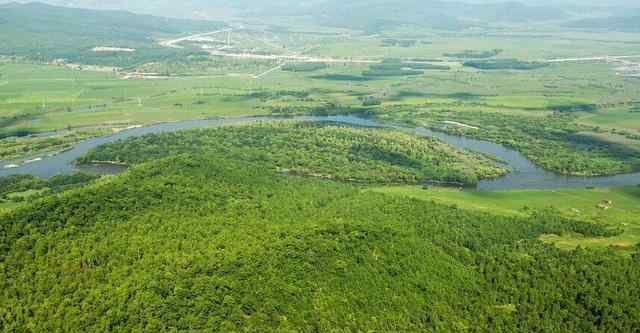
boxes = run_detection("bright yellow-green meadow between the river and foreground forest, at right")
[371,186,640,251]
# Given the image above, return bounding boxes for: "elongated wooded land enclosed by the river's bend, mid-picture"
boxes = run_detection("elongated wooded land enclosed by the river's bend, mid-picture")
[80,121,506,185]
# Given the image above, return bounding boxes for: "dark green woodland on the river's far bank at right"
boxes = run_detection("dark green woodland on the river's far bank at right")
[380,105,640,176]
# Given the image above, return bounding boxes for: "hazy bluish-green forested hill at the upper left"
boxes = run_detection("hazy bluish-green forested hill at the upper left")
[0,3,223,65]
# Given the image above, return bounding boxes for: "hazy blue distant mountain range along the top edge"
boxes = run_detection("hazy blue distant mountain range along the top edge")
[6,0,640,31]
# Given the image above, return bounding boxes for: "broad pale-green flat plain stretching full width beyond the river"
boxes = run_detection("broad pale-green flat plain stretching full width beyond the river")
[0,37,640,130]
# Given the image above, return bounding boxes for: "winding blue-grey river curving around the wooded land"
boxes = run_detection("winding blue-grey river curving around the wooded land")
[0,116,640,190]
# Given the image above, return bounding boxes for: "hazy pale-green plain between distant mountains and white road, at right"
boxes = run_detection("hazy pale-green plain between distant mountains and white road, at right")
[304,28,640,60]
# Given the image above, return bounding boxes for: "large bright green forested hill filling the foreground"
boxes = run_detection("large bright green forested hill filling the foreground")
[0,152,640,332]
